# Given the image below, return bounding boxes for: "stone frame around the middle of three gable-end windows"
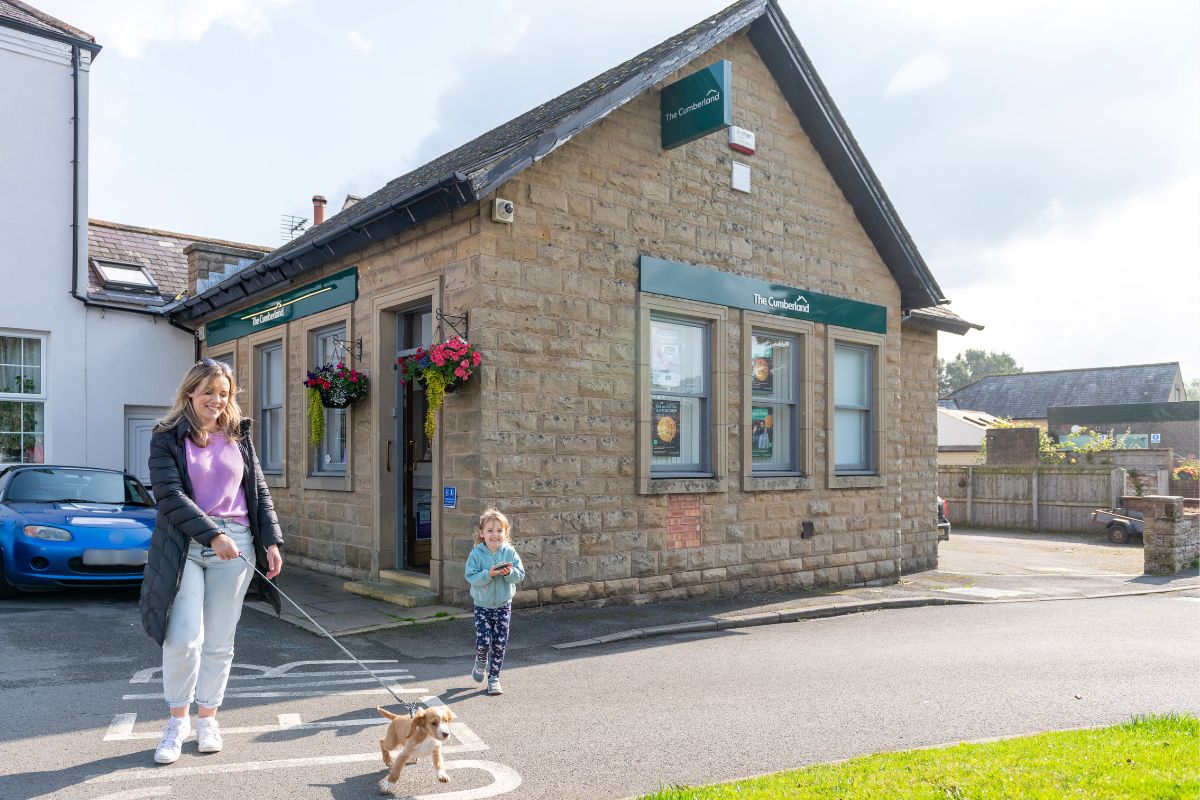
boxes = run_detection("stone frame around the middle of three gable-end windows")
[739,311,816,492]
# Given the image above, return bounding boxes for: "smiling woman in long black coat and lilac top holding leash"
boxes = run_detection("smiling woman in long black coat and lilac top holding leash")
[140,359,283,764]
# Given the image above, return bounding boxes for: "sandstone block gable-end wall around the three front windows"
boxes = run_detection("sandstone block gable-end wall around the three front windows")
[446,32,907,603]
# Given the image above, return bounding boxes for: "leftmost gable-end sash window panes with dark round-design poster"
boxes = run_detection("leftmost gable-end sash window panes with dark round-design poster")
[649,315,712,476]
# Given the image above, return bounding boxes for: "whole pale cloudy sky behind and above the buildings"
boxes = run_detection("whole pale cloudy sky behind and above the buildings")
[34,0,1200,380]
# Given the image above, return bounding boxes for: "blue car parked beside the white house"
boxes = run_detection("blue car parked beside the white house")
[0,464,155,597]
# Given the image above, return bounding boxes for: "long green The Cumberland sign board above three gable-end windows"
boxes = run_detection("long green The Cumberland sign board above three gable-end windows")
[638,255,888,333]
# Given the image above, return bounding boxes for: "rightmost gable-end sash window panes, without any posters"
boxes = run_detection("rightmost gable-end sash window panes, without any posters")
[833,342,878,475]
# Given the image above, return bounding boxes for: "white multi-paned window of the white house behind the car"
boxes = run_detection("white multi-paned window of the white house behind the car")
[0,333,47,464]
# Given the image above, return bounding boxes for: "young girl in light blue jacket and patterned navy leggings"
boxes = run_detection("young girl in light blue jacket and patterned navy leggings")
[466,509,524,694]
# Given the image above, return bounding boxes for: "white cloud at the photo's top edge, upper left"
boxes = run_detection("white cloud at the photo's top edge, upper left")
[42,0,294,59]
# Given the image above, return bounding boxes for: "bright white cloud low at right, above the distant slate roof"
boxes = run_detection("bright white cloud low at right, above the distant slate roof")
[940,175,1200,380]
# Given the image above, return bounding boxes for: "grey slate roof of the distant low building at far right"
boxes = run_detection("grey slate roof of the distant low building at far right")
[938,361,1180,420]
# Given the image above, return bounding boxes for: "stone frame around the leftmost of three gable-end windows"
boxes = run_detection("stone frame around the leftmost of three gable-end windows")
[635,293,728,494]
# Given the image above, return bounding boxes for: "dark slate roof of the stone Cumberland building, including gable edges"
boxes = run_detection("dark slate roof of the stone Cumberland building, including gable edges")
[170,0,944,323]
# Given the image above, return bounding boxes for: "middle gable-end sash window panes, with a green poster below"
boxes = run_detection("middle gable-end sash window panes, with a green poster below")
[748,330,803,475]
